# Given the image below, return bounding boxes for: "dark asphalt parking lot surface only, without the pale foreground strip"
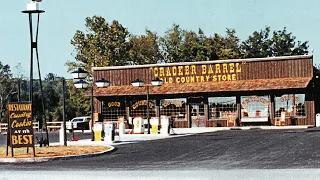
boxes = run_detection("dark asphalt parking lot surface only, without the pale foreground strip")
[0,128,320,170]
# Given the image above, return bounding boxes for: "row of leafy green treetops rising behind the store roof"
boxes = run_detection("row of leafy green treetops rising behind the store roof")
[66,16,308,72]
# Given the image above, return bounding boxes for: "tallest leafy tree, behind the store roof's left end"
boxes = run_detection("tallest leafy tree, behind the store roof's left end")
[66,16,130,72]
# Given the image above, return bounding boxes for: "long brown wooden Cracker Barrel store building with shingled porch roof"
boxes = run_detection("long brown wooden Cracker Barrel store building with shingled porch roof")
[93,55,315,128]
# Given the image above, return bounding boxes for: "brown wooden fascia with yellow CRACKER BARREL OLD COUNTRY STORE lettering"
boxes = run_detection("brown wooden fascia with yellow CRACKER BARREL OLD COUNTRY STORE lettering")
[93,55,313,87]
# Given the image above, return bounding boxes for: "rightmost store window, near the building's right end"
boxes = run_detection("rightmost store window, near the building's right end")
[274,94,306,117]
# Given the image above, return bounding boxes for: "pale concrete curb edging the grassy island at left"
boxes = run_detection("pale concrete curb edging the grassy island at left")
[0,146,117,164]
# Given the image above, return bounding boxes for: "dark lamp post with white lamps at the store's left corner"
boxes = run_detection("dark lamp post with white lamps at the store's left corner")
[72,68,110,141]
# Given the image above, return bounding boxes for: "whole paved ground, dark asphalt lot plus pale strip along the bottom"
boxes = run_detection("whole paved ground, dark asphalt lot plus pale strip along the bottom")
[0,127,320,179]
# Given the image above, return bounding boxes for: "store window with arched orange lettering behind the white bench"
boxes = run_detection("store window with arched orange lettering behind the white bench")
[241,96,270,122]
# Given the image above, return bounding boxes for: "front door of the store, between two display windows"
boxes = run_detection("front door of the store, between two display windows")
[190,103,206,127]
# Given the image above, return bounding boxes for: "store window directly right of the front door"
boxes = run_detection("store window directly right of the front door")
[208,97,237,120]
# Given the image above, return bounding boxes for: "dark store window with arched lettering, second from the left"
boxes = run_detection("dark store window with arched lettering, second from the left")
[130,100,156,119]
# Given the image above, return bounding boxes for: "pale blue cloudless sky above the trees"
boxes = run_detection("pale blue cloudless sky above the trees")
[0,0,320,78]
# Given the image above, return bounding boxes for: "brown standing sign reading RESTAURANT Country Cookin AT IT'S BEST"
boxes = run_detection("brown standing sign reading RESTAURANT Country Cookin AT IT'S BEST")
[7,102,35,156]
